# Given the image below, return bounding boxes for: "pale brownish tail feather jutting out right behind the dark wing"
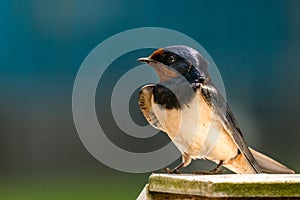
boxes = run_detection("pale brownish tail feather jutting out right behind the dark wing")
[249,148,295,174]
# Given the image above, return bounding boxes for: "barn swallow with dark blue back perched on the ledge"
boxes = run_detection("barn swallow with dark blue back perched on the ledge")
[138,46,295,174]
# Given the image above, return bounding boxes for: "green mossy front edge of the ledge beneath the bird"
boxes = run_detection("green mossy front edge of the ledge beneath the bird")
[149,174,300,197]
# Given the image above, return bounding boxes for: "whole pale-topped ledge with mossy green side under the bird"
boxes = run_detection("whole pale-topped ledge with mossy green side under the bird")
[139,174,300,199]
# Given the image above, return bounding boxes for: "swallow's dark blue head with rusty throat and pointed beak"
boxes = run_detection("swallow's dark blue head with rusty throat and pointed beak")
[138,46,209,83]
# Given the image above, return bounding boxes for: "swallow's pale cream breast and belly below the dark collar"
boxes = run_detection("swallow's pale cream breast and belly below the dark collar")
[151,91,237,160]
